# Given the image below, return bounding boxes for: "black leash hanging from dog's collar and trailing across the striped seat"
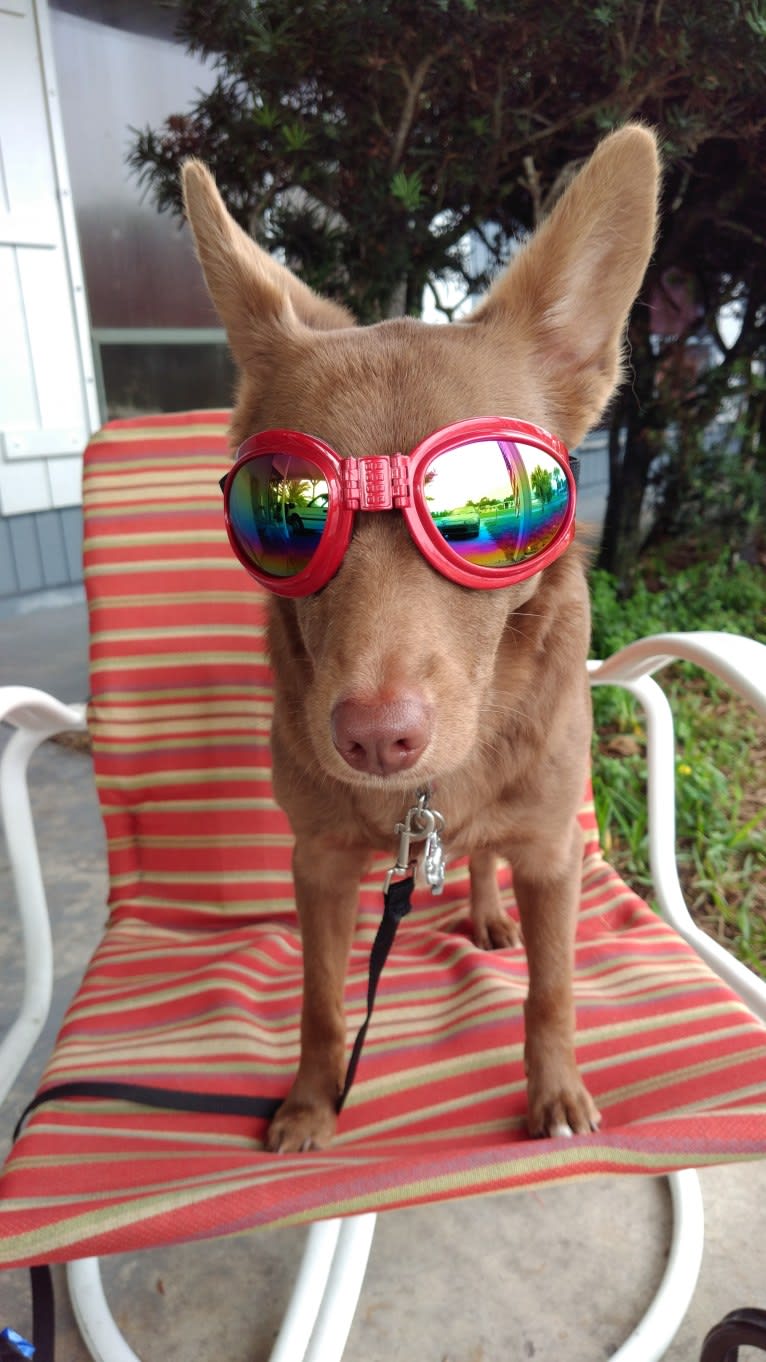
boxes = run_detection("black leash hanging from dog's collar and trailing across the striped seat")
[14,874,414,1362]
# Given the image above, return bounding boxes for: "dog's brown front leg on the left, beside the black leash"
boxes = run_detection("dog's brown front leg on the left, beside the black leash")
[266,838,369,1154]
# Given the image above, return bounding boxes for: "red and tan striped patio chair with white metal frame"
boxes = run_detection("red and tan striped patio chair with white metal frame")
[0,411,766,1362]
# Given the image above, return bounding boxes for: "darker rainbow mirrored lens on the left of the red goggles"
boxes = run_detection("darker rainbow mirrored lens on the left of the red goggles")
[229,454,330,577]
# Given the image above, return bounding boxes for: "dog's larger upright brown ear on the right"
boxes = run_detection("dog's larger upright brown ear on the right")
[472,124,660,443]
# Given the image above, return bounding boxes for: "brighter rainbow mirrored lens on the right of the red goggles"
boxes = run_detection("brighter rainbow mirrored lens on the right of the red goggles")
[423,440,570,568]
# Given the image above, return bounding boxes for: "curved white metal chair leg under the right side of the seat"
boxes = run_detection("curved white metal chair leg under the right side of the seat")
[611,1169,703,1362]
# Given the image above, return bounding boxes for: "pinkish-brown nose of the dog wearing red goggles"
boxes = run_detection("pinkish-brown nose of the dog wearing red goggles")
[331,693,432,775]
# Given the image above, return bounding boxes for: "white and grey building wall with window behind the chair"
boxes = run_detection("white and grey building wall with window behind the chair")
[0,0,232,601]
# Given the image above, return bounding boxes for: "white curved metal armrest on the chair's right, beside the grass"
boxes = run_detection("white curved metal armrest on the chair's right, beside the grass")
[587,631,766,1022]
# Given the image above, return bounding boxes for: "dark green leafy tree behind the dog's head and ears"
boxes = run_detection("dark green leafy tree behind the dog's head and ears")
[129,0,766,579]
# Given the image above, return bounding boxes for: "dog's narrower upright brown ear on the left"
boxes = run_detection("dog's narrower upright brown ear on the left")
[181,159,354,369]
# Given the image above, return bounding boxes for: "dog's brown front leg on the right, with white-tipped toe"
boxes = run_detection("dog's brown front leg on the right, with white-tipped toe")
[514,825,600,1136]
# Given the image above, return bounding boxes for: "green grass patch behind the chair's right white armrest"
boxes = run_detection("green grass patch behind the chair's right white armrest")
[592,550,766,977]
